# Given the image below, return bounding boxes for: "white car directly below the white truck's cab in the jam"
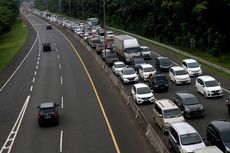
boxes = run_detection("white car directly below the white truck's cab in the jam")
[120,67,139,83]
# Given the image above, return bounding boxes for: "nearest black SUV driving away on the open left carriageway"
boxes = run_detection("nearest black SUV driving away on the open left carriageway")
[38,102,59,126]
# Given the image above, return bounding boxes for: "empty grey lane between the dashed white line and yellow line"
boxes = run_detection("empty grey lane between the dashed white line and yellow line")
[33,18,119,152]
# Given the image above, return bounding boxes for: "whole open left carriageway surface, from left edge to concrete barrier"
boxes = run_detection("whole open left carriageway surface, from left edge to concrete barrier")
[0,15,154,153]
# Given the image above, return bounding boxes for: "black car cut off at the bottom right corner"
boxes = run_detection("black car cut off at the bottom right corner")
[206,120,230,153]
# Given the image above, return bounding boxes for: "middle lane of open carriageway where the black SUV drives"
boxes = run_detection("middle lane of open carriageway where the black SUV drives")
[9,16,61,152]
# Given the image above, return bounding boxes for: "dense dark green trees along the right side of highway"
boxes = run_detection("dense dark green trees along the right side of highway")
[35,0,230,56]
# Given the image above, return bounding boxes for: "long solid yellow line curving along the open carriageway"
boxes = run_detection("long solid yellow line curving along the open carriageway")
[55,28,120,153]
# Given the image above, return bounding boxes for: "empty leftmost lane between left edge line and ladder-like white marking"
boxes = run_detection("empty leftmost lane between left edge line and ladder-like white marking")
[0,35,39,146]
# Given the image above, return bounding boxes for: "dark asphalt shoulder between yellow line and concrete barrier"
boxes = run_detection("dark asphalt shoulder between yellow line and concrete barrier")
[55,27,156,153]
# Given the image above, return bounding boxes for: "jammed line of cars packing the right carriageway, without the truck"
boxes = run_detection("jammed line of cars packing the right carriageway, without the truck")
[32,9,230,153]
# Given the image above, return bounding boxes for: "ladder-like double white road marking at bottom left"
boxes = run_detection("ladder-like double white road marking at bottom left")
[0,95,30,153]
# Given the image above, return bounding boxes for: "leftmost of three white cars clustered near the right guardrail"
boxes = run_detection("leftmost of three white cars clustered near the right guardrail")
[169,66,191,84]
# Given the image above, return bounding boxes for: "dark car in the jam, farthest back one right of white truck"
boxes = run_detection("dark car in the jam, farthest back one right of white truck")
[155,56,172,72]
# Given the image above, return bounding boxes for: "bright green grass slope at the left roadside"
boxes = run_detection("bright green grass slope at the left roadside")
[0,21,28,70]
